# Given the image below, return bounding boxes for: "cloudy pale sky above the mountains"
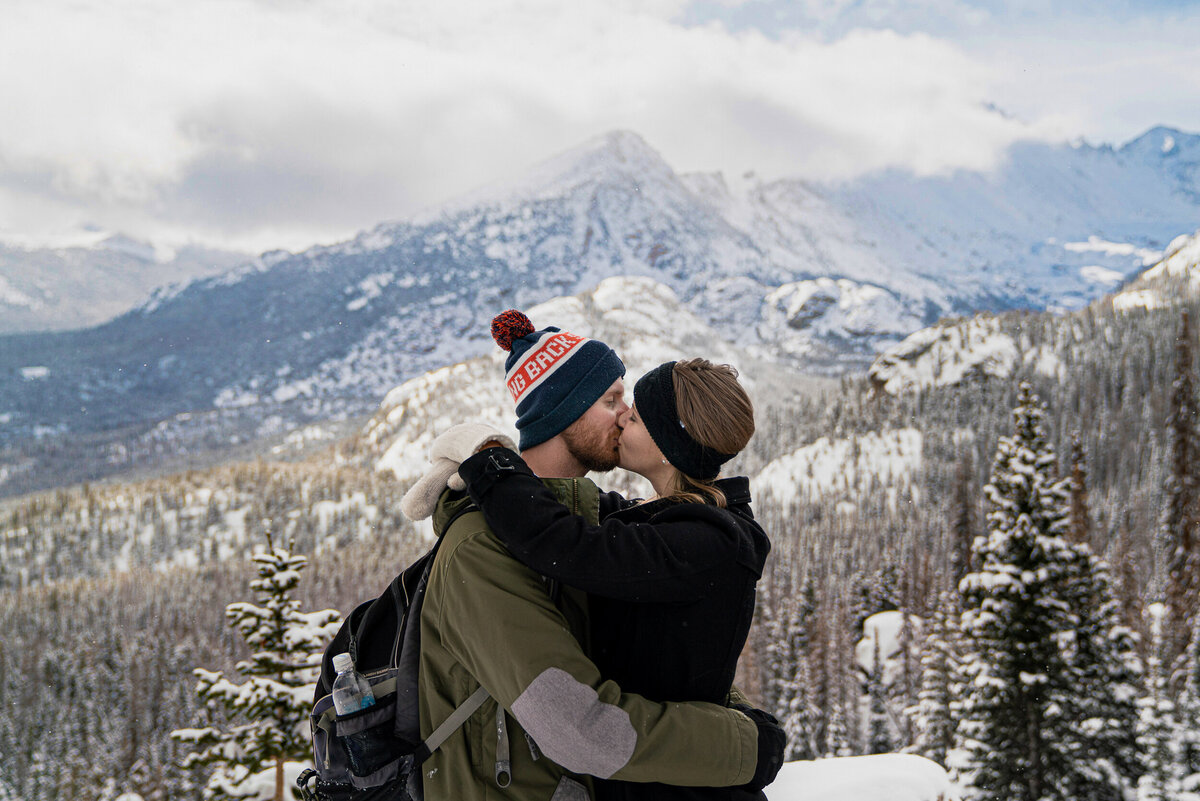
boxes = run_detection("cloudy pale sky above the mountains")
[0,0,1200,251]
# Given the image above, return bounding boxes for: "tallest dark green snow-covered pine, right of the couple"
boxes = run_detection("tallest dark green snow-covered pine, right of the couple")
[958,383,1135,801]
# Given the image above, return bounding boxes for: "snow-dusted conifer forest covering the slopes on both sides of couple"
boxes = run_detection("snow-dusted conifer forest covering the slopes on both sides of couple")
[0,282,1200,801]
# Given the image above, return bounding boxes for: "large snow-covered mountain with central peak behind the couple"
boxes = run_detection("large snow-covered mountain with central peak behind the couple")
[0,128,1200,494]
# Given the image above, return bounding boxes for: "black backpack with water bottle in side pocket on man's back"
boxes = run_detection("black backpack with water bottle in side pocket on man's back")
[296,505,488,801]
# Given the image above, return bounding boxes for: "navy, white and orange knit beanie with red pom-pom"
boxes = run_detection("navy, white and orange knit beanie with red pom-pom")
[492,309,625,451]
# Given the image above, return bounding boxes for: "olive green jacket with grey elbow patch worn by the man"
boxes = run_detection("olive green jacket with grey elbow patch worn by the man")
[420,478,758,801]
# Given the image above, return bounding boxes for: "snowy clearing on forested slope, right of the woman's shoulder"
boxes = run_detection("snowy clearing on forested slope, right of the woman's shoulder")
[752,428,924,507]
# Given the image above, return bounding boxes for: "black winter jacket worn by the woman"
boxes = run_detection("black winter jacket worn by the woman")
[458,448,770,801]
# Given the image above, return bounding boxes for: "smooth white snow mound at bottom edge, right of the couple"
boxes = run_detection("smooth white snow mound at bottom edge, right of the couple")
[767,754,959,801]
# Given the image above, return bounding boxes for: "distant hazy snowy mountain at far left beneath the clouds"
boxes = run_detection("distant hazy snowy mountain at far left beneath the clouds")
[0,230,250,333]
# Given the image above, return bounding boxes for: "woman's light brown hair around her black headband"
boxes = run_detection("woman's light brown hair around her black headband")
[666,359,754,508]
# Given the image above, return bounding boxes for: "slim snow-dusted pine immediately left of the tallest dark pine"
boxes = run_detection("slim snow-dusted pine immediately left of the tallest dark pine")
[906,592,958,766]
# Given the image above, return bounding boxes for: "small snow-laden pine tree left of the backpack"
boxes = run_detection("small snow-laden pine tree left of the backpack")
[172,534,341,801]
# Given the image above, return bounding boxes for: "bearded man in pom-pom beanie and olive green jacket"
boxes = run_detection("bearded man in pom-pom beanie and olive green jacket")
[406,312,782,801]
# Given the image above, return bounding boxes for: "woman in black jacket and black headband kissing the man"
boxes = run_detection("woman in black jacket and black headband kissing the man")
[458,359,770,800]
